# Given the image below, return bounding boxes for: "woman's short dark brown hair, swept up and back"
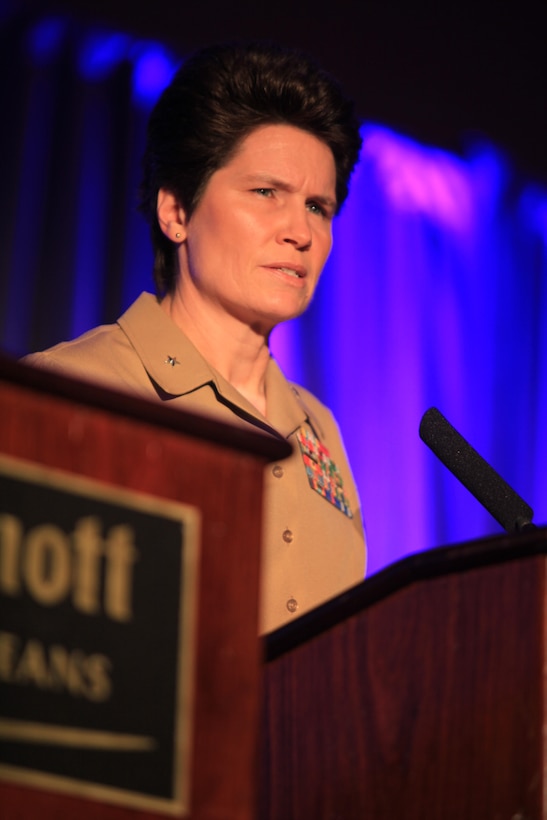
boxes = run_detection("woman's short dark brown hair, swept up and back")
[139,44,361,295]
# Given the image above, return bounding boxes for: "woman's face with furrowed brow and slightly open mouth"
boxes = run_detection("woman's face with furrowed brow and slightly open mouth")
[177,125,336,334]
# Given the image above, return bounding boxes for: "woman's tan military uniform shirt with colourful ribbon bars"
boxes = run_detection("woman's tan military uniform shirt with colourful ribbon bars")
[25,293,365,632]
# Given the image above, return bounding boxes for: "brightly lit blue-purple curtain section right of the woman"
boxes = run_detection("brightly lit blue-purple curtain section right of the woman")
[274,131,547,571]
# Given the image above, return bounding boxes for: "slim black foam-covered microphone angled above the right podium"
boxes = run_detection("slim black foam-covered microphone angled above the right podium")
[420,407,535,533]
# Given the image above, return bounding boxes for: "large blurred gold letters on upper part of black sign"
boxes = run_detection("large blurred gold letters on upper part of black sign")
[0,514,138,621]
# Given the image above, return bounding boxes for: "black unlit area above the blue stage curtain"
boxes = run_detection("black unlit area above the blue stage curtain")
[10,0,547,182]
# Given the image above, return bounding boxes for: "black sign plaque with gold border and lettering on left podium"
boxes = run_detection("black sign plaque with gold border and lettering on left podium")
[0,456,200,815]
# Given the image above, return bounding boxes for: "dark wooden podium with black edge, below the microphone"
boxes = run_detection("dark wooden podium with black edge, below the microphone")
[258,529,547,820]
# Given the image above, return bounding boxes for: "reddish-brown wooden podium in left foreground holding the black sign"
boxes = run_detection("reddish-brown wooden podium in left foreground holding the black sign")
[0,361,290,820]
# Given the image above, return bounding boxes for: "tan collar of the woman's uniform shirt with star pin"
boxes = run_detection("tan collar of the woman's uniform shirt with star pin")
[118,293,310,438]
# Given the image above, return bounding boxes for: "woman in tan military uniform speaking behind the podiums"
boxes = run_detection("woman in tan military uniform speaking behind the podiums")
[27,46,365,631]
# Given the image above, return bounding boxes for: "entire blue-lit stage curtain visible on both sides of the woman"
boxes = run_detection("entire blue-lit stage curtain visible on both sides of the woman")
[0,16,547,573]
